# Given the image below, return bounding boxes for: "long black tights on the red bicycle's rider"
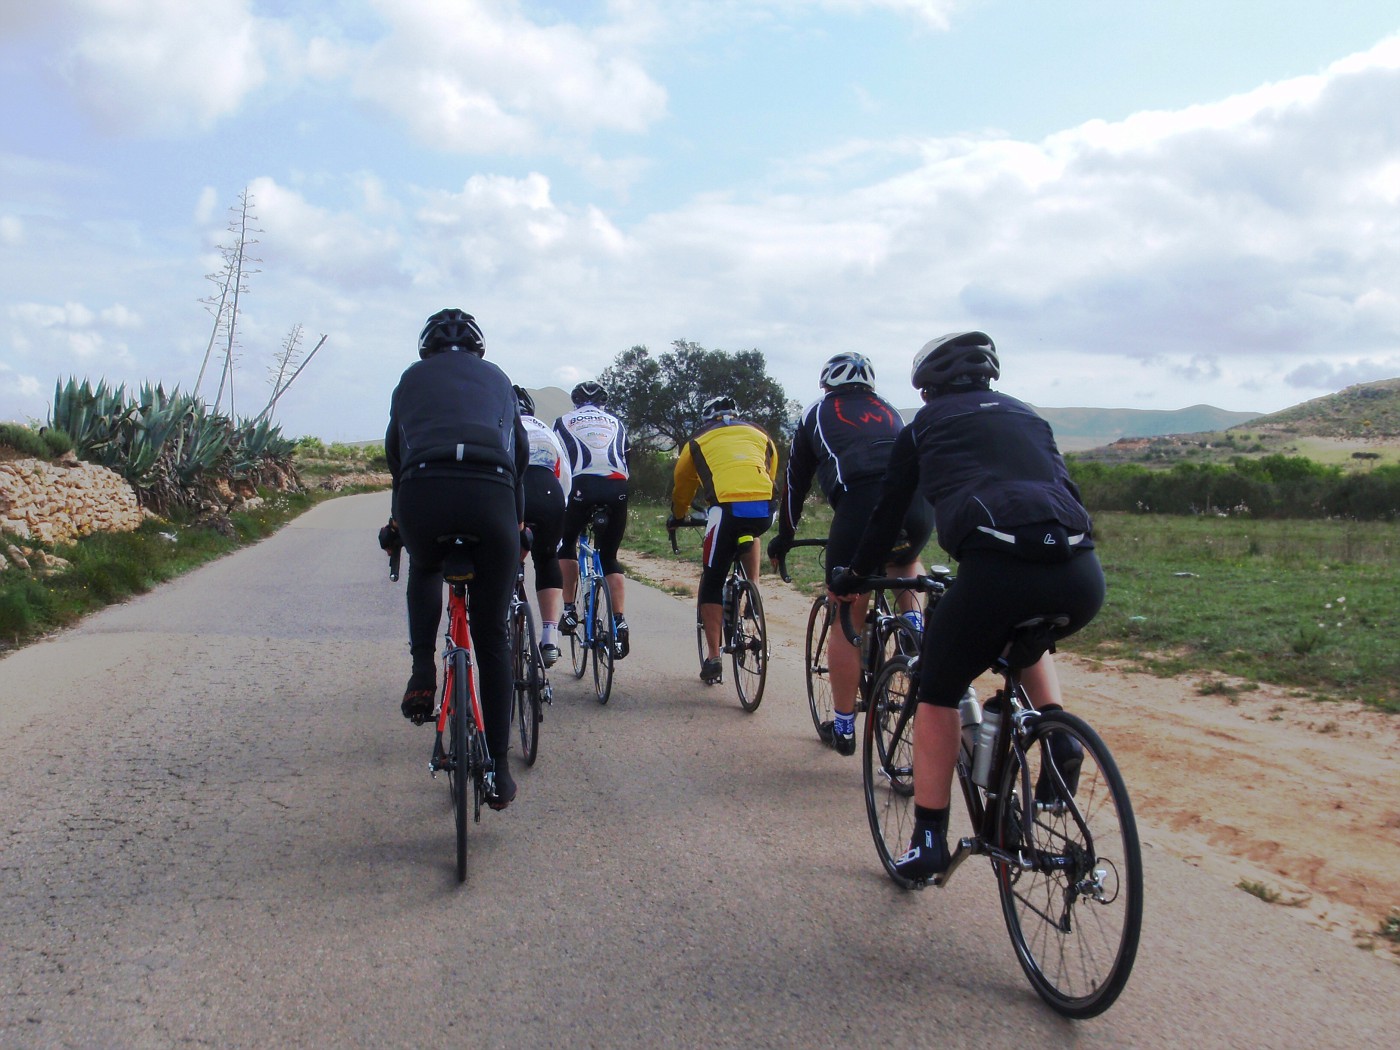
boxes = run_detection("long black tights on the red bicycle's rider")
[395,477,521,756]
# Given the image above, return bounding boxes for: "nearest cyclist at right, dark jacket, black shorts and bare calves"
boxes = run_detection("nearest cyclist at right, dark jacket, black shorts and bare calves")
[832,332,1103,881]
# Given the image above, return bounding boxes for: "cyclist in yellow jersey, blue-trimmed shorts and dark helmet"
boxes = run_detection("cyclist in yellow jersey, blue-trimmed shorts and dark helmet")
[666,398,778,685]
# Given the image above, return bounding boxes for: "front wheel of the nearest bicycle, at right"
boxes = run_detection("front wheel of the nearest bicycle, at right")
[862,657,918,889]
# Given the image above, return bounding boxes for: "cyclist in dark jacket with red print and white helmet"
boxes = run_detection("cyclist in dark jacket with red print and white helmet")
[769,353,934,755]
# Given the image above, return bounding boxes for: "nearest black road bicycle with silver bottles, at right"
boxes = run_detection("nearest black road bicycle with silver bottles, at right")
[841,575,1142,1018]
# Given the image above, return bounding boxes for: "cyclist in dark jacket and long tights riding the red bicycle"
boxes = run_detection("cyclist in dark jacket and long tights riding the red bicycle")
[384,309,529,809]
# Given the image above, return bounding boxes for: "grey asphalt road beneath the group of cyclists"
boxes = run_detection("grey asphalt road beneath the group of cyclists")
[0,494,1400,1047]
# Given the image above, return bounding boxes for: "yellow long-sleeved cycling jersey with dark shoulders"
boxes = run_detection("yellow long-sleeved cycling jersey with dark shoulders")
[671,419,778,518]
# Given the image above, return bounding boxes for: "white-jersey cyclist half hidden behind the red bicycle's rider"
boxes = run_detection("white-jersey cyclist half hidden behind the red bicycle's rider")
[515,386,573,666]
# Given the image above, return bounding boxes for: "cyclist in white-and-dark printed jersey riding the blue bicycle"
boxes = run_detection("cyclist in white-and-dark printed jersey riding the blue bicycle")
[554,379,631,659]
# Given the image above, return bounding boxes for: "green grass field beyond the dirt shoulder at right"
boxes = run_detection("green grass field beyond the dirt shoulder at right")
[623,503,1400,711]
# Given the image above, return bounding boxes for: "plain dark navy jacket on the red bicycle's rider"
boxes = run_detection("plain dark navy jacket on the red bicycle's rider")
[384,350,529,521]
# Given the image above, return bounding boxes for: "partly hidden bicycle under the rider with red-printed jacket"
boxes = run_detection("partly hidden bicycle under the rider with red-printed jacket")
[778,538,918,736]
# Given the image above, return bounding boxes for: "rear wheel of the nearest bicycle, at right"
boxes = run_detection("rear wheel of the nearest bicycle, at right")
[993,711,1142,1018]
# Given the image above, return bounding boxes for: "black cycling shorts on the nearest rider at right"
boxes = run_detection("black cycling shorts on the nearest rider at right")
[918,550,1103,707]
